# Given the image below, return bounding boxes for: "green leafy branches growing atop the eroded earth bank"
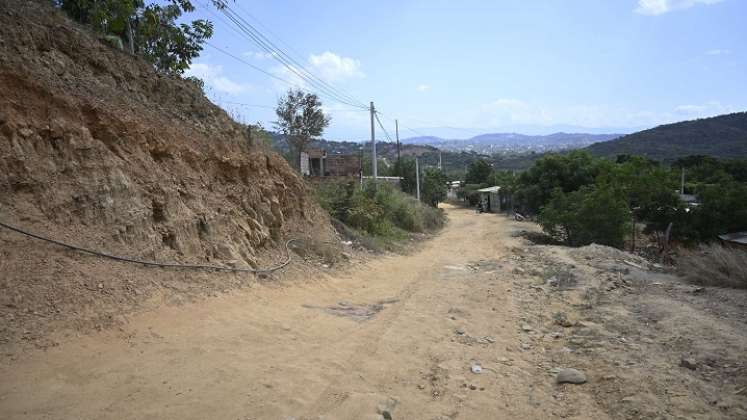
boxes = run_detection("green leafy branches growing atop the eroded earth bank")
[53,0,216,74]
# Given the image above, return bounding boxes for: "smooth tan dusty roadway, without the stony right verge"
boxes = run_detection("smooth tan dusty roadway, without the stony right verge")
[0,208,605,419]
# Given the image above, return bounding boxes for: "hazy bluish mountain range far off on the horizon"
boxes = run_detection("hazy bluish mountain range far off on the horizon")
[402,133,622,155]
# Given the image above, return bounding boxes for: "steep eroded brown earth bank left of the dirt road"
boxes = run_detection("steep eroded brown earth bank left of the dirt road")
[0,0,333,352]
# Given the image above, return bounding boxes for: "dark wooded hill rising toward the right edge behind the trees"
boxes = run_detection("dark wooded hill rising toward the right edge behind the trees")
[587,112,747,161]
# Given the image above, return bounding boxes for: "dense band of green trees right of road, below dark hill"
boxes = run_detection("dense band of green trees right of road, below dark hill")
[516,151,747,248]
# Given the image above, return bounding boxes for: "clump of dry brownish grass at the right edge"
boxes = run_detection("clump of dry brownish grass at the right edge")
[677,244,747,289]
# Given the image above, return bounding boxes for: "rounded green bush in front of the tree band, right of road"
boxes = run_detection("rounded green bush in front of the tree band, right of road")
[538,185,630,248]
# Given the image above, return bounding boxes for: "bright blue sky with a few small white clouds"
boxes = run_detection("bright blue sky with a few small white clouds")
[188,0,747,140]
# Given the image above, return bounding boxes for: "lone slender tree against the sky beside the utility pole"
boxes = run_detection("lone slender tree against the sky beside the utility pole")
[275,89,330,169]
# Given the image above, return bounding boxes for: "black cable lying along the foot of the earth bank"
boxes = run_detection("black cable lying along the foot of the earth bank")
[0,222,297,274]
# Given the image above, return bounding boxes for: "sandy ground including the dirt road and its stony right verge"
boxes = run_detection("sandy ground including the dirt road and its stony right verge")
[0,207,747,419]
